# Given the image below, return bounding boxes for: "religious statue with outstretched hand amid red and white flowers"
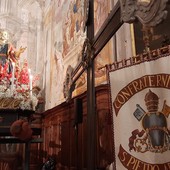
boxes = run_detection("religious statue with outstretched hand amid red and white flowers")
[0,29,42,110]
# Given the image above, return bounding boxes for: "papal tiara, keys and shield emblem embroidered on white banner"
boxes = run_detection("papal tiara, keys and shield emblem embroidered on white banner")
[129,90,170,153]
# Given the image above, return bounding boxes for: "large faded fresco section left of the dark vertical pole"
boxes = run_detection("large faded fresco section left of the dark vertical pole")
[50,0,86,107]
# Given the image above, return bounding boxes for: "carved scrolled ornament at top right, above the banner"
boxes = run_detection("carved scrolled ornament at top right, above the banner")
[120,0,168,27]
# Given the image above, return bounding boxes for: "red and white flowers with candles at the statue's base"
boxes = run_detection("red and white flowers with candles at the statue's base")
[0,60,41,110]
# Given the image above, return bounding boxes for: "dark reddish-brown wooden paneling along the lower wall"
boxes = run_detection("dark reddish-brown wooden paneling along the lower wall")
[42,85,113,170]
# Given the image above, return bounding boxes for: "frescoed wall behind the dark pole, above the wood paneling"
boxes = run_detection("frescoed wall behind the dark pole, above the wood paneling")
[50,0,115,107]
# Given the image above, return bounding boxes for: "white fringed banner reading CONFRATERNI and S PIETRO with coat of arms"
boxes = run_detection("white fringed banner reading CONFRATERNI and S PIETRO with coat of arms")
[108,46,170,170]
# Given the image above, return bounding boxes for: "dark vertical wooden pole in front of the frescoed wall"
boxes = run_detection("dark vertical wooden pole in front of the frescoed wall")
[87,0,96,170]
